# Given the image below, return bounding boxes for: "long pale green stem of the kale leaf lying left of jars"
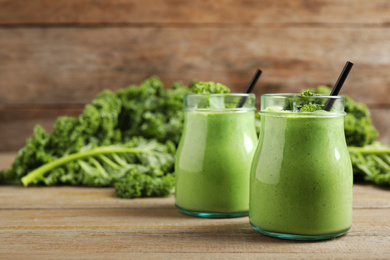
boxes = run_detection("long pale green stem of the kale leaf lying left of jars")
[22,146,153,186]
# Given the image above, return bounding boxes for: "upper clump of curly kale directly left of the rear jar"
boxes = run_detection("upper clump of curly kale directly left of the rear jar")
[117,78,190,145]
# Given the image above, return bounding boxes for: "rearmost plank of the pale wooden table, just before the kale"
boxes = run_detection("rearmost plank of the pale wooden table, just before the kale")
[0,184,390,210]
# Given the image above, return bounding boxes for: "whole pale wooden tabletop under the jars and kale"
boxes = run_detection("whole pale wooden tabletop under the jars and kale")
[0,154,390,259]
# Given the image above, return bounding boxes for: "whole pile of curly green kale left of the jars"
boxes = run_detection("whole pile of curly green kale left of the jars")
[0,78,190,198]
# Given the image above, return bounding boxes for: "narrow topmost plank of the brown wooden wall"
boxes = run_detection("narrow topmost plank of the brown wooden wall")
[0,0,390,25]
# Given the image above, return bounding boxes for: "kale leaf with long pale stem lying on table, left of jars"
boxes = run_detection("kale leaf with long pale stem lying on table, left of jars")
[22,137,175,197]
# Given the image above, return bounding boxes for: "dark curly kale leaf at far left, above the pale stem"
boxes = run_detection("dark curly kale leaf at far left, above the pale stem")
[0,91,121,184]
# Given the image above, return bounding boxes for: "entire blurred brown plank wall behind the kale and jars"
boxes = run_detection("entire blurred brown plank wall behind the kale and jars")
[0,0,390,151]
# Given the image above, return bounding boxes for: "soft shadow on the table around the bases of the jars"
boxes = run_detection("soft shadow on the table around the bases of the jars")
[96,205,344,247]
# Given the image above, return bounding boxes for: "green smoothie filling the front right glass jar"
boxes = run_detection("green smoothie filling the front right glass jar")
[249,110,352,239]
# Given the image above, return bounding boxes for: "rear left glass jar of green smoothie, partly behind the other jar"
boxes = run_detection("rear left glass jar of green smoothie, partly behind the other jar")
[175,94,257,218]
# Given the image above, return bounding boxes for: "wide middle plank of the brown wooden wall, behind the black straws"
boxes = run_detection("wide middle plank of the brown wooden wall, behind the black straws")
[0,27,390,106]
